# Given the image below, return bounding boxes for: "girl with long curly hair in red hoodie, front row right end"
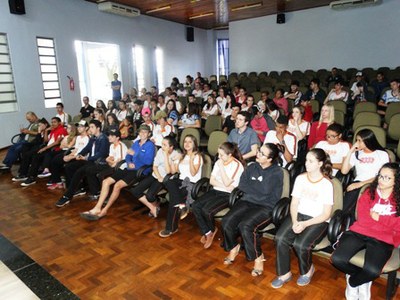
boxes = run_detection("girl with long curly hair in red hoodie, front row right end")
[331,163,400,299]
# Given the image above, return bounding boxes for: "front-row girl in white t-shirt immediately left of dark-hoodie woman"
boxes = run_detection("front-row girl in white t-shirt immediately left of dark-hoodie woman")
[193,142,245,249]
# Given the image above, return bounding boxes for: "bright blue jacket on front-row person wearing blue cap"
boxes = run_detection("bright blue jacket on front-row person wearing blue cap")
[125,140,156,175]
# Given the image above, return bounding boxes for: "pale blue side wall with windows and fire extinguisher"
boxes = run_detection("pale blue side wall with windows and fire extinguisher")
[0,0,213,148]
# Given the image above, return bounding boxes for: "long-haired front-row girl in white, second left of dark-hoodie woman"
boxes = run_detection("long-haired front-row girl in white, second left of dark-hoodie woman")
[159,134,203,238]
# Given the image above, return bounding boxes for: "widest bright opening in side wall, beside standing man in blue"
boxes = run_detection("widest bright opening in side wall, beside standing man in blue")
[75,41,123,106]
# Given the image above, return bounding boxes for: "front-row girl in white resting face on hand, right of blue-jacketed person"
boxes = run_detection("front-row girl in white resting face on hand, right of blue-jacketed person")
[131,136,181,218]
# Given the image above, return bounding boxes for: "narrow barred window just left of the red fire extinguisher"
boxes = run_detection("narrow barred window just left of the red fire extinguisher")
[36,37,61,108]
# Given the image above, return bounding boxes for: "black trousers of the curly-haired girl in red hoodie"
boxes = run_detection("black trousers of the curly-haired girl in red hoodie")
[331,231,393,287]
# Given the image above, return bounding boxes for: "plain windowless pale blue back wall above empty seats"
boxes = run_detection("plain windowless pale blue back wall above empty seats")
[229,0,400,72]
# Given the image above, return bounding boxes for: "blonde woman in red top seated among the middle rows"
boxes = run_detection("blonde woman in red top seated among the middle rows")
[307,104,335,149]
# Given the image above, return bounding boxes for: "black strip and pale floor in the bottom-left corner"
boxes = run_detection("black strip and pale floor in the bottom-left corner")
[0,234,79,300]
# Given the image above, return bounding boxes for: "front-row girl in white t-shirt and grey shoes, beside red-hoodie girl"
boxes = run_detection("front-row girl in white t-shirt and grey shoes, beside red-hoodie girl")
[271,149,333,289]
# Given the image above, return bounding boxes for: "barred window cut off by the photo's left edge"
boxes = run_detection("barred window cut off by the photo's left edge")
[0,33,18,113]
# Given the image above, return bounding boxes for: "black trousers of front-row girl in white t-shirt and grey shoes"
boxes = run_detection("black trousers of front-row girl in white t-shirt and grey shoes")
[275,213,328,276]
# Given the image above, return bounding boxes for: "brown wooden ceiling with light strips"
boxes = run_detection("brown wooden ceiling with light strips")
[85,0,332,29]
